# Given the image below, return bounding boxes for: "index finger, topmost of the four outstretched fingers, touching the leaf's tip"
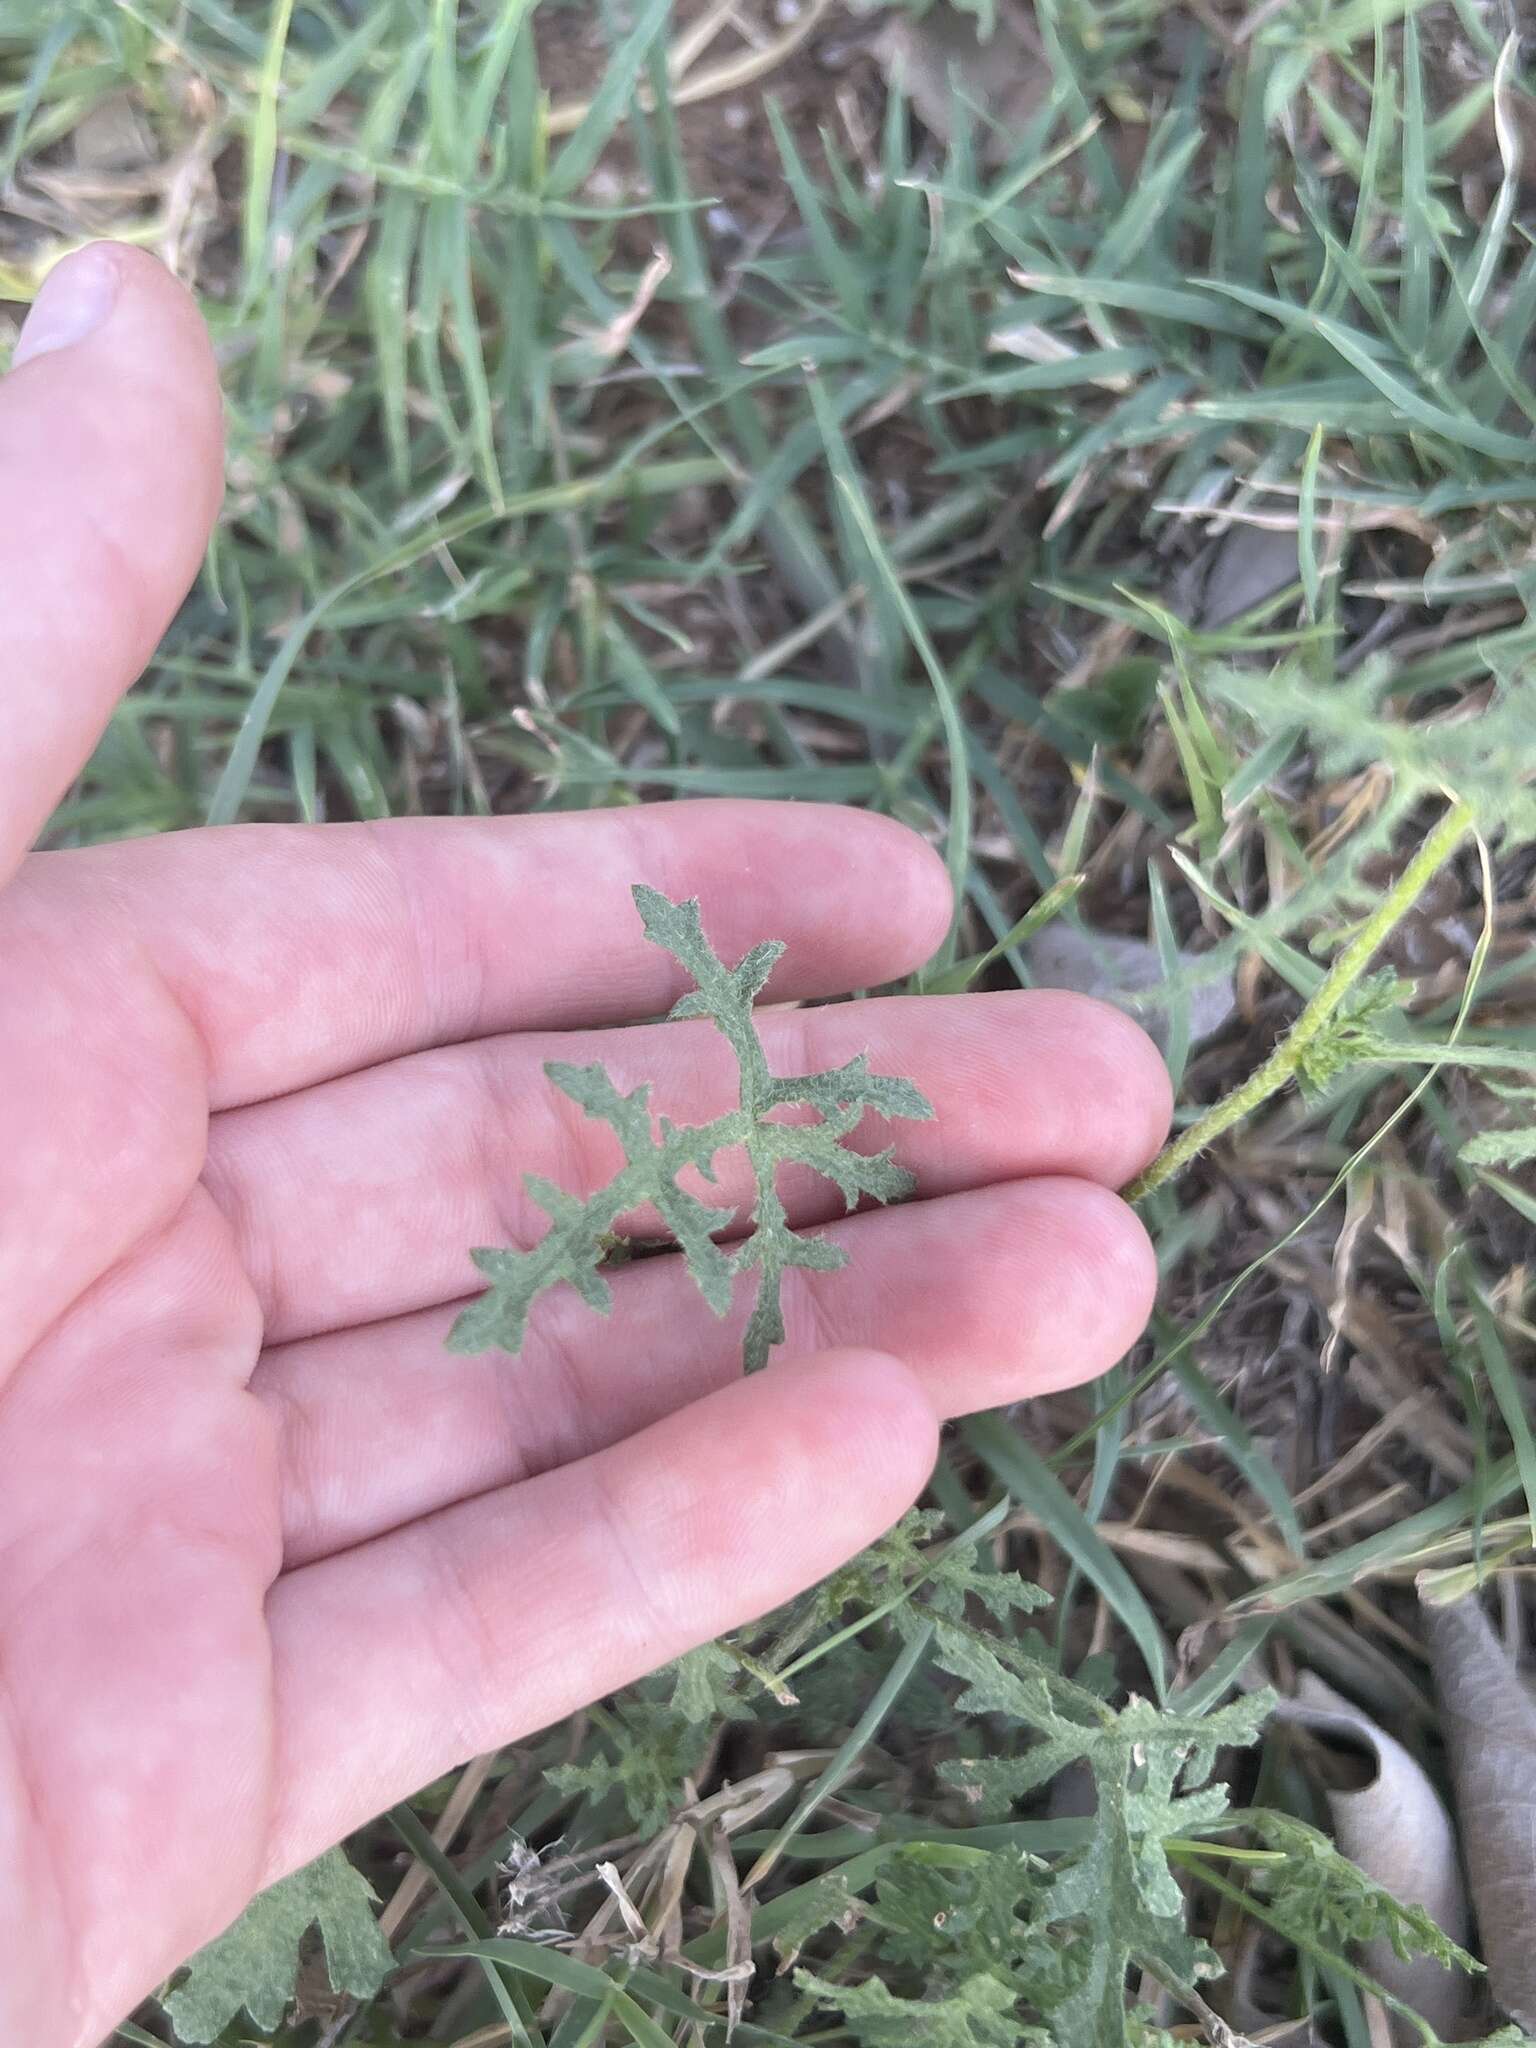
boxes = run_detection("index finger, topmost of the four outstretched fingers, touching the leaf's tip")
[27,799,950,1110]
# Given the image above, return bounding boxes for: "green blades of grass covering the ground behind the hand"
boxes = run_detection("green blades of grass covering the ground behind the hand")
[0,0,1536,2048]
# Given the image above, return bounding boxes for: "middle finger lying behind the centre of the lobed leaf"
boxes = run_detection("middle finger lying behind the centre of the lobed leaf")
[205,991,1167,1343]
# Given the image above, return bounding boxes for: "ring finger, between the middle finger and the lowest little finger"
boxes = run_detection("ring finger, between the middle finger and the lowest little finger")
[262,1180,1155,1567]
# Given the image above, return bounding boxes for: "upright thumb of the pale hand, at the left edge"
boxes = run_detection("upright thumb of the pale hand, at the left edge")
[0,242,223,881]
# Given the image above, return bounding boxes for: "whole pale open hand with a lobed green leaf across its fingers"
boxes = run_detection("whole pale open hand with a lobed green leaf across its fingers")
[0,248,1167,2048]
